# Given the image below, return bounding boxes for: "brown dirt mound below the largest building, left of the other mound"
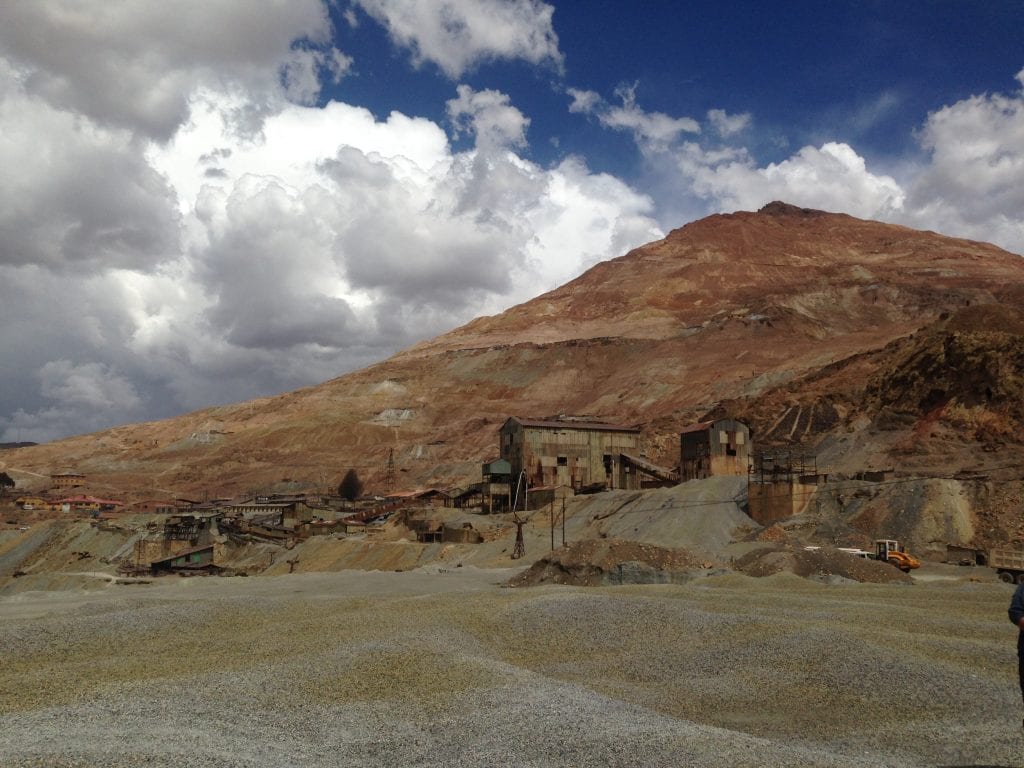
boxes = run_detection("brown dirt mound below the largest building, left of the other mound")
[508,539,715,587]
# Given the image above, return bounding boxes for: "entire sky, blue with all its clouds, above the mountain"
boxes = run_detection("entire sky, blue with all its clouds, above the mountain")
[0,0,1024,440]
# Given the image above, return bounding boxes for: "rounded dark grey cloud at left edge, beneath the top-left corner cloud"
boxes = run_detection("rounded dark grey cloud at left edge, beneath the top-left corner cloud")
[0,79,178,270]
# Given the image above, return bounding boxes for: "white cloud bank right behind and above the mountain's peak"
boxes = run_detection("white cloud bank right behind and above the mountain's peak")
[568,70,1024,253]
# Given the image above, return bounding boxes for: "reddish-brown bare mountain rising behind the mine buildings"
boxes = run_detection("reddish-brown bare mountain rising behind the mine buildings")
[0,203,1024,507]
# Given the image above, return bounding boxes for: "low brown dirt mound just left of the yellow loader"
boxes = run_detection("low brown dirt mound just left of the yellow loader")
[733,547,913,584]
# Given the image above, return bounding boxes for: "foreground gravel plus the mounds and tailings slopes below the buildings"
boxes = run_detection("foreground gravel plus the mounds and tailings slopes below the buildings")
[0,478,1024,768]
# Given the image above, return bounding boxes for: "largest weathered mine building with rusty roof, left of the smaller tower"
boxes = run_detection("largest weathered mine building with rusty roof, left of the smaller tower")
[499,416,640,499]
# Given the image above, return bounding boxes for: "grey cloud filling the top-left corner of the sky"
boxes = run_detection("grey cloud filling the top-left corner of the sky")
[0,0,330,140]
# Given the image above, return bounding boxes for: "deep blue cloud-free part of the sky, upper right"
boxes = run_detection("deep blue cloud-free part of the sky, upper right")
[331,0,1024,180]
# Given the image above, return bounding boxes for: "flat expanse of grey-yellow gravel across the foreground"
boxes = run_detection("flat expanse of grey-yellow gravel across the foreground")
[0,567,1024,768]
